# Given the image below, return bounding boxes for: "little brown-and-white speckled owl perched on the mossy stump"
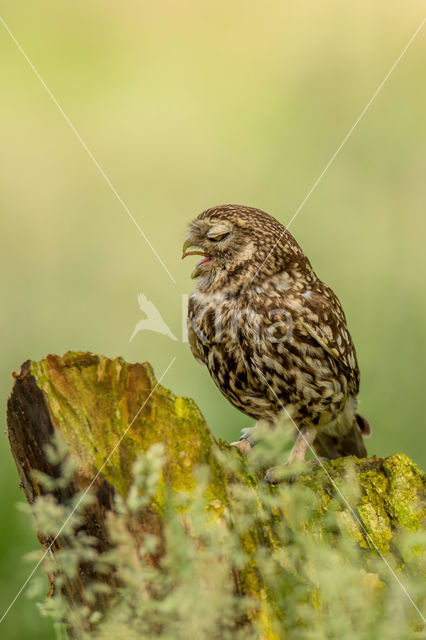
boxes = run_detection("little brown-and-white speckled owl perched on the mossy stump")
[182,205,370,478]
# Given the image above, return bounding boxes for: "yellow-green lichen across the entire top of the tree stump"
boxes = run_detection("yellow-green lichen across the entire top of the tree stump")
[7,352,426,639]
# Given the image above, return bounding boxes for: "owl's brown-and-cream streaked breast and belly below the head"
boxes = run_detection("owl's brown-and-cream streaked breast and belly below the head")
[188,282,348,424]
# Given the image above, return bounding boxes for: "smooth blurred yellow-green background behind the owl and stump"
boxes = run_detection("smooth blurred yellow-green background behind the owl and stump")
[0,0,426,640]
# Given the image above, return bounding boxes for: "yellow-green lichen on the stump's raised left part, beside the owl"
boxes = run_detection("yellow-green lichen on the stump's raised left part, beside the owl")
[30,351,224,502]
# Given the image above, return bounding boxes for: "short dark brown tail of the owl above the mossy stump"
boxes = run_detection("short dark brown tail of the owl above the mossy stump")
[314,413,371,460]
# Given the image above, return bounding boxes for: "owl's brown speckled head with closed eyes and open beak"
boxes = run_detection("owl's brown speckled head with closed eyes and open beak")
[182,204,303,286]
